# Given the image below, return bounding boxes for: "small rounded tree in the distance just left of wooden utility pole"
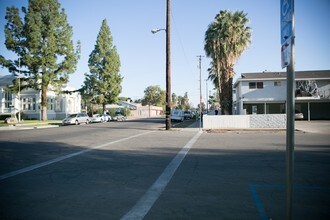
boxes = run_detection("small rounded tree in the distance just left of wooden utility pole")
[142,86,166,107]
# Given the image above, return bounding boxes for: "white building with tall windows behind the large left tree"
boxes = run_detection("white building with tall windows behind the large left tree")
[0,75,81,120]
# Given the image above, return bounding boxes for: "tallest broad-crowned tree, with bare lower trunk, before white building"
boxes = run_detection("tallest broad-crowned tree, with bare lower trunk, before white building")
[0,0,80,120]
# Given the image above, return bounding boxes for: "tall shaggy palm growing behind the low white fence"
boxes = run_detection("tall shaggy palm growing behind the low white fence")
[204,10,251,114]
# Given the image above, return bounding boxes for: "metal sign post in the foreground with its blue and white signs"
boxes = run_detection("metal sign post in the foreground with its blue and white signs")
[281,0,295,220]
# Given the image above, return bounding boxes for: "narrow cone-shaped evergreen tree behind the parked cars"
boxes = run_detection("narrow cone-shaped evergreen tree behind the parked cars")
[83,19,123,111]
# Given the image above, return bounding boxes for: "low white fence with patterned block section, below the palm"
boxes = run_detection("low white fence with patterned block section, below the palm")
[203,114,286,129]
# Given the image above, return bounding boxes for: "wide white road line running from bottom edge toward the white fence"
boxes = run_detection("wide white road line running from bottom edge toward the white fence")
[121,132,202,220]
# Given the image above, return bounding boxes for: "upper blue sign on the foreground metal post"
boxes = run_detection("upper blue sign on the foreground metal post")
[281,0,293,44]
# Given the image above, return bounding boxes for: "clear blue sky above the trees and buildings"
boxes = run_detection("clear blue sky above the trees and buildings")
[0,0,330,106]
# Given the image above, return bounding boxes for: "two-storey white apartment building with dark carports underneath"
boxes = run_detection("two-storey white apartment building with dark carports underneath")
[233,70,330,120]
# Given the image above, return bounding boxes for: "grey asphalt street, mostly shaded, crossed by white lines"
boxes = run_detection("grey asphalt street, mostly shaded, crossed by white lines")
[0,119,330,219]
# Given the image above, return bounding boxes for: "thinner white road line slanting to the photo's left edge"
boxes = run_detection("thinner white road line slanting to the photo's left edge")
[0,131,155,181]
